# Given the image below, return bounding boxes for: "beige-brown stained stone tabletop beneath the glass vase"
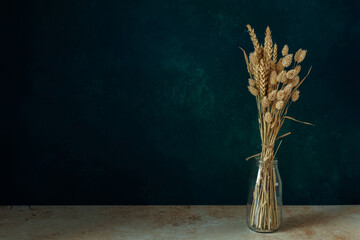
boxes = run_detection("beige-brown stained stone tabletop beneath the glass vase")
[0,205,360,240]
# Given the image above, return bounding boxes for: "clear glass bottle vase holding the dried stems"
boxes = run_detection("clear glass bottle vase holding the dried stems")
[246,157,282,232]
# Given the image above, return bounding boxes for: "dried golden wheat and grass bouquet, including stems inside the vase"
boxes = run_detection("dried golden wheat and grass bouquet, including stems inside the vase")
[241,25,311,230]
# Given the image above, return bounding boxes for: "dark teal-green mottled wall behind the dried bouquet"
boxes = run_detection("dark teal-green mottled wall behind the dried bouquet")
[0,0,360,204]
